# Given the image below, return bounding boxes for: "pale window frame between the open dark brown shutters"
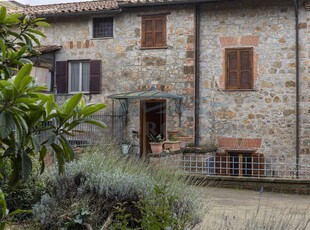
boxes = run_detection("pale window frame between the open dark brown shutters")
[68,60,90,94]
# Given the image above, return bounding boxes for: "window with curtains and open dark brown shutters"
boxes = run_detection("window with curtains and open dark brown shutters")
[56,60,101,94]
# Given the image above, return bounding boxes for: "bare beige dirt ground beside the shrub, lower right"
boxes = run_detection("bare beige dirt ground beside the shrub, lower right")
[196,188,310,230]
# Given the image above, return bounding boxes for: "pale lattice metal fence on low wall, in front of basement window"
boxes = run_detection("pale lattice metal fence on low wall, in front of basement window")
[174,155,310,179]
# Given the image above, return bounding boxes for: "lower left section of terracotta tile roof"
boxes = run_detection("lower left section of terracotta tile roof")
[19,0,118,15]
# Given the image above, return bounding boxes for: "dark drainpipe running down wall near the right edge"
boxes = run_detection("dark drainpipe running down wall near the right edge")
[293,0,300,178]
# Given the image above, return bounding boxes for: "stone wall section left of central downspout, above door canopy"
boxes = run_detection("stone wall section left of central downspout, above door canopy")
[43,7,195,135]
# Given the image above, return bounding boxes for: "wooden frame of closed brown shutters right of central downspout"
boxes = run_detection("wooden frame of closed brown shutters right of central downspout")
[225,47,254,90]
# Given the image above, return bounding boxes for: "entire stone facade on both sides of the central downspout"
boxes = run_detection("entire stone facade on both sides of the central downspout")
[37,0,310,162]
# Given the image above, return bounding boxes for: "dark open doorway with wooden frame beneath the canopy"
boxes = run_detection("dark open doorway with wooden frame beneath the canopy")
[140,100,166,156]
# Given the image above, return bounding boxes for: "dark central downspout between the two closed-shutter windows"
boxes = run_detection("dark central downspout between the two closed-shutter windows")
[195,4,200,146]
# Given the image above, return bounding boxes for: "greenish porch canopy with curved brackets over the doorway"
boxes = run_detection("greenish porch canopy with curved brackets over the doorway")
[108,89,183,116]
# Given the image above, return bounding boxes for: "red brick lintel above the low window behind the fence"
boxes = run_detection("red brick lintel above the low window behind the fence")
[217,137,262,150]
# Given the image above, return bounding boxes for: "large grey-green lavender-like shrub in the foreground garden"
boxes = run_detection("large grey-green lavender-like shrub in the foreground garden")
[34,146,203,229]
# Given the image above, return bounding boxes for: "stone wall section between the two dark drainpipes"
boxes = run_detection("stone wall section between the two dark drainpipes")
[200,1,296,157]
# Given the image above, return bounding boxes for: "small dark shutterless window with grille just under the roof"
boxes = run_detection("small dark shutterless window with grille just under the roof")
[93,17,113,38]
